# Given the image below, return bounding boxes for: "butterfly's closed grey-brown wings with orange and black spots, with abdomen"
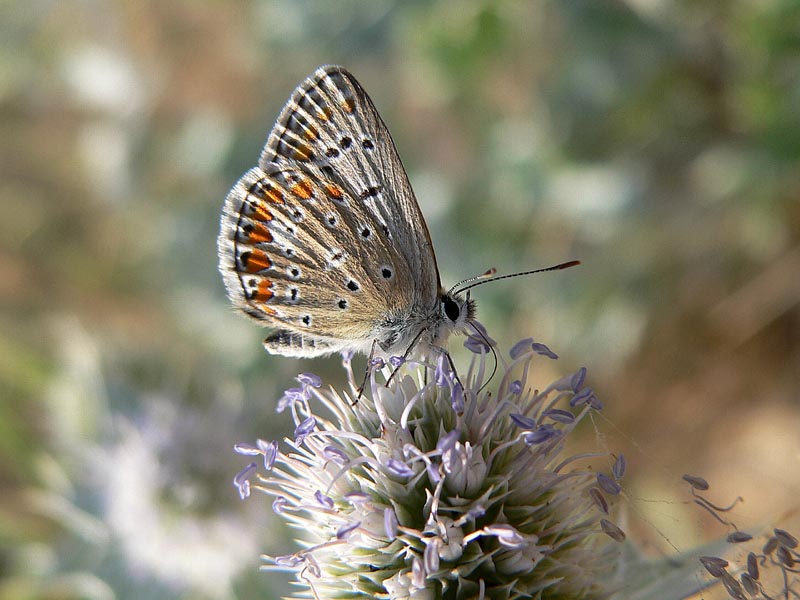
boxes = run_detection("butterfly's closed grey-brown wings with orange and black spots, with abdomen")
[218,67,439,356]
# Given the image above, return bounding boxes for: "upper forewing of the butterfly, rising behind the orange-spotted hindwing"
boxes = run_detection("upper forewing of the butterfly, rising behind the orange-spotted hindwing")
[259,66,439,306]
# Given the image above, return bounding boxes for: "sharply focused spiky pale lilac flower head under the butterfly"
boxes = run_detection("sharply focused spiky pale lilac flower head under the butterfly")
[234,334,624,599]
